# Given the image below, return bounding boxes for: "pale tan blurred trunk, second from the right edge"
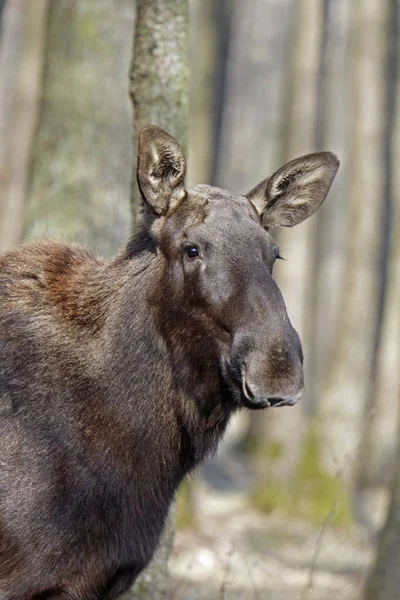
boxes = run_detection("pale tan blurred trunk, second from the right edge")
[320,0,389,481]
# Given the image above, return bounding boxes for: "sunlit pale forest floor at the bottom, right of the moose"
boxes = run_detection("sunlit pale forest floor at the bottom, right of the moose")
[168,483,375,600]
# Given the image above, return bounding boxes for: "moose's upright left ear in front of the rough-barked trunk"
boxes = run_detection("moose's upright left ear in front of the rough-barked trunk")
[137,125,186,215]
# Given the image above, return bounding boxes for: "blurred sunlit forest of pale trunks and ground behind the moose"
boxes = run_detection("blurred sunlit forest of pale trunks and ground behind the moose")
[0,0,400,600]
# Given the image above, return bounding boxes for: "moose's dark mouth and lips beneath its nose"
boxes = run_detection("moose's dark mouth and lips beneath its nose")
[222,361,300,410]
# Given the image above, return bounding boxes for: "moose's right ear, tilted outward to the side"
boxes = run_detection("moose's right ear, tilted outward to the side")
[247,152,339,228]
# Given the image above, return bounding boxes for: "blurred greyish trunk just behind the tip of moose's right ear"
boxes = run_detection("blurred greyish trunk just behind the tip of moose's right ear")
[308,0,351,414]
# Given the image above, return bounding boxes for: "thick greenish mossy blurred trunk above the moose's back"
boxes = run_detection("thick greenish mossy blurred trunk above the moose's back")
[26,0,134,256]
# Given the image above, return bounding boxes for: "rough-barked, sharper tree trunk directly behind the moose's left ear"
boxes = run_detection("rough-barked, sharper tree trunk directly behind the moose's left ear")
[124,0,189,600]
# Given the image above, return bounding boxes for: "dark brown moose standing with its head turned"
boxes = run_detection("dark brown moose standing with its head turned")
[0,125,339,600]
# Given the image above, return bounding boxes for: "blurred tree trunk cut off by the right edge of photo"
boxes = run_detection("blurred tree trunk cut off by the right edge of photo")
[358,0,400,490]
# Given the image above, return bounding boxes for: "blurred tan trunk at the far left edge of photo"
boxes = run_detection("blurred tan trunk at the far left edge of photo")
[0,0,48,252]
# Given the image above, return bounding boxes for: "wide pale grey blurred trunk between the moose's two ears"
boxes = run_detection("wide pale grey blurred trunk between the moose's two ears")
[215,0,294,468]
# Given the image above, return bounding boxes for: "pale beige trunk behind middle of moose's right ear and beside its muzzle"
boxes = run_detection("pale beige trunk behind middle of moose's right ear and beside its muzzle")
[268,0,324,482]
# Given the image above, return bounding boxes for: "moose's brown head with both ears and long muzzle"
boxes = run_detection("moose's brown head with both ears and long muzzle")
[138,125,339,409]
